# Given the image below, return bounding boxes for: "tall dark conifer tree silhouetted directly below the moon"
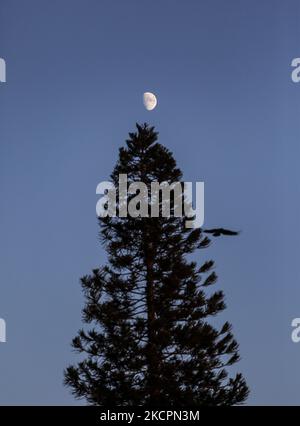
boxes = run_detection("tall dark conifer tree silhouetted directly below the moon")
[65,124,248,407]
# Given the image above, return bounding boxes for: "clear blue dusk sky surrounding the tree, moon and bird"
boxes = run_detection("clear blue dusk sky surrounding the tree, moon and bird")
[0,0,300,404]
